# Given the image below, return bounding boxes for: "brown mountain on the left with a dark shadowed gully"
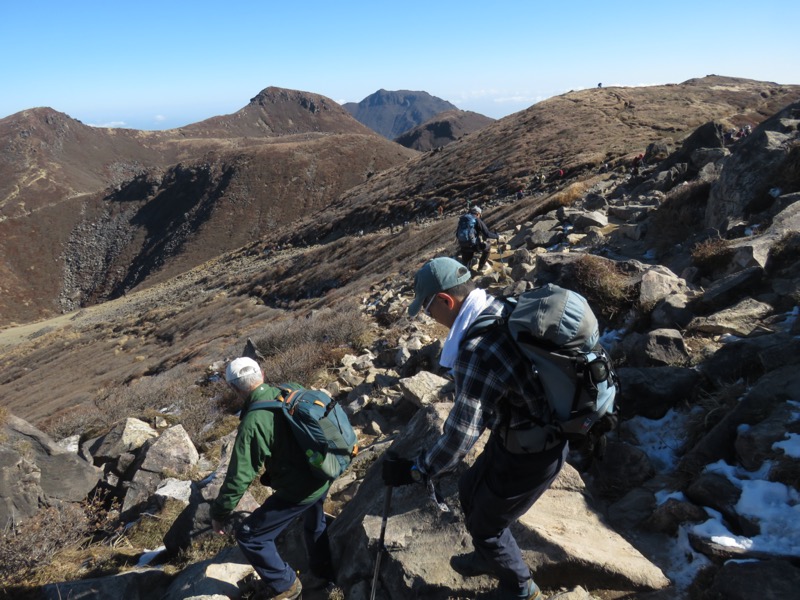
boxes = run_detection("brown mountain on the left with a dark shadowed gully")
[0,88,413,324]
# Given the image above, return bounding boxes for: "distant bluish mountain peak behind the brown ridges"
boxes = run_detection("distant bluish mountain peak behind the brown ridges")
[342,89,457,140]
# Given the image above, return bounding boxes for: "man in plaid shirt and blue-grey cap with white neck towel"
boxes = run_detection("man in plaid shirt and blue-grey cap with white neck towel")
[383,258,568,600]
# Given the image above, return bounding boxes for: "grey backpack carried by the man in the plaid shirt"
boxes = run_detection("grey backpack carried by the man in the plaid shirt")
[467,284,619,445]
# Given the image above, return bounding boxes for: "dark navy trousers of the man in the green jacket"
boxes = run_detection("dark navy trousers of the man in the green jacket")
[236,494,332,594]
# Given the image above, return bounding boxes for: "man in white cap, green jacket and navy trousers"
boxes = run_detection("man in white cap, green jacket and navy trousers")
[211,357,333,600]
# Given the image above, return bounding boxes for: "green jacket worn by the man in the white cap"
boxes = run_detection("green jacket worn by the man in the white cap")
[211,384,330,521]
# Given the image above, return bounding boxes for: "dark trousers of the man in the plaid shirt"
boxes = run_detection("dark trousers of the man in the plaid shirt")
[458,435,567,589]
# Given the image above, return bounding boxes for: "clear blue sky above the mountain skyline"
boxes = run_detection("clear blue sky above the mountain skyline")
[0,0,800,129]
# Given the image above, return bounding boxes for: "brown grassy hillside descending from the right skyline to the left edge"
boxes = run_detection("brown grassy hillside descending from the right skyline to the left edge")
[0,78,800,422]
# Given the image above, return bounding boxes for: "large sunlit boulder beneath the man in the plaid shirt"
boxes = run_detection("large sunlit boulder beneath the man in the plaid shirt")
[330,403,669,600]
